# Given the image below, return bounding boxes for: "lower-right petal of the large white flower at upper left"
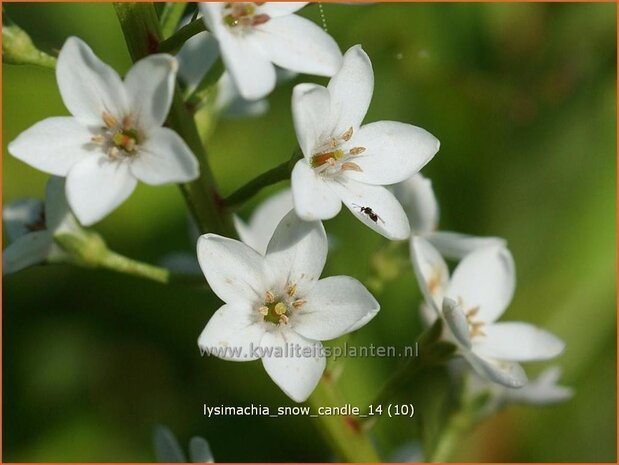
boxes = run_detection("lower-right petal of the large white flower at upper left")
[130,127,200,186]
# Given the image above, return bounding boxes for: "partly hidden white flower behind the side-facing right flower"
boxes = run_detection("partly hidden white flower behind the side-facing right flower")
[392,173,506,260]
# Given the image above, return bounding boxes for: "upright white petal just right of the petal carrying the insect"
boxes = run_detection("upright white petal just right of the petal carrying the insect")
[393,173,440,236]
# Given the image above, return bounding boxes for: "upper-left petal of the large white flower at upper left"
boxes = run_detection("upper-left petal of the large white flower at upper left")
[56,37,127,126]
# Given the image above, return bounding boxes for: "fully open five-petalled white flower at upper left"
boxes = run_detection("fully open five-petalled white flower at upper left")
[9,37,198,225]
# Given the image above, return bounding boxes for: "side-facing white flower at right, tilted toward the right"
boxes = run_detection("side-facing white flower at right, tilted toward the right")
[411,237,564,387]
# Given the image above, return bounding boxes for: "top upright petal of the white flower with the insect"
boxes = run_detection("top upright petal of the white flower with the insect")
[328,45,374,135]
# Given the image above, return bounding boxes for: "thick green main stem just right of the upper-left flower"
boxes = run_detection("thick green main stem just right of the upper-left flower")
[114,2,236,237]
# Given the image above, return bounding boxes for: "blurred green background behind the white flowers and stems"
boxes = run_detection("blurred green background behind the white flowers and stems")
[2,3,617,462]
